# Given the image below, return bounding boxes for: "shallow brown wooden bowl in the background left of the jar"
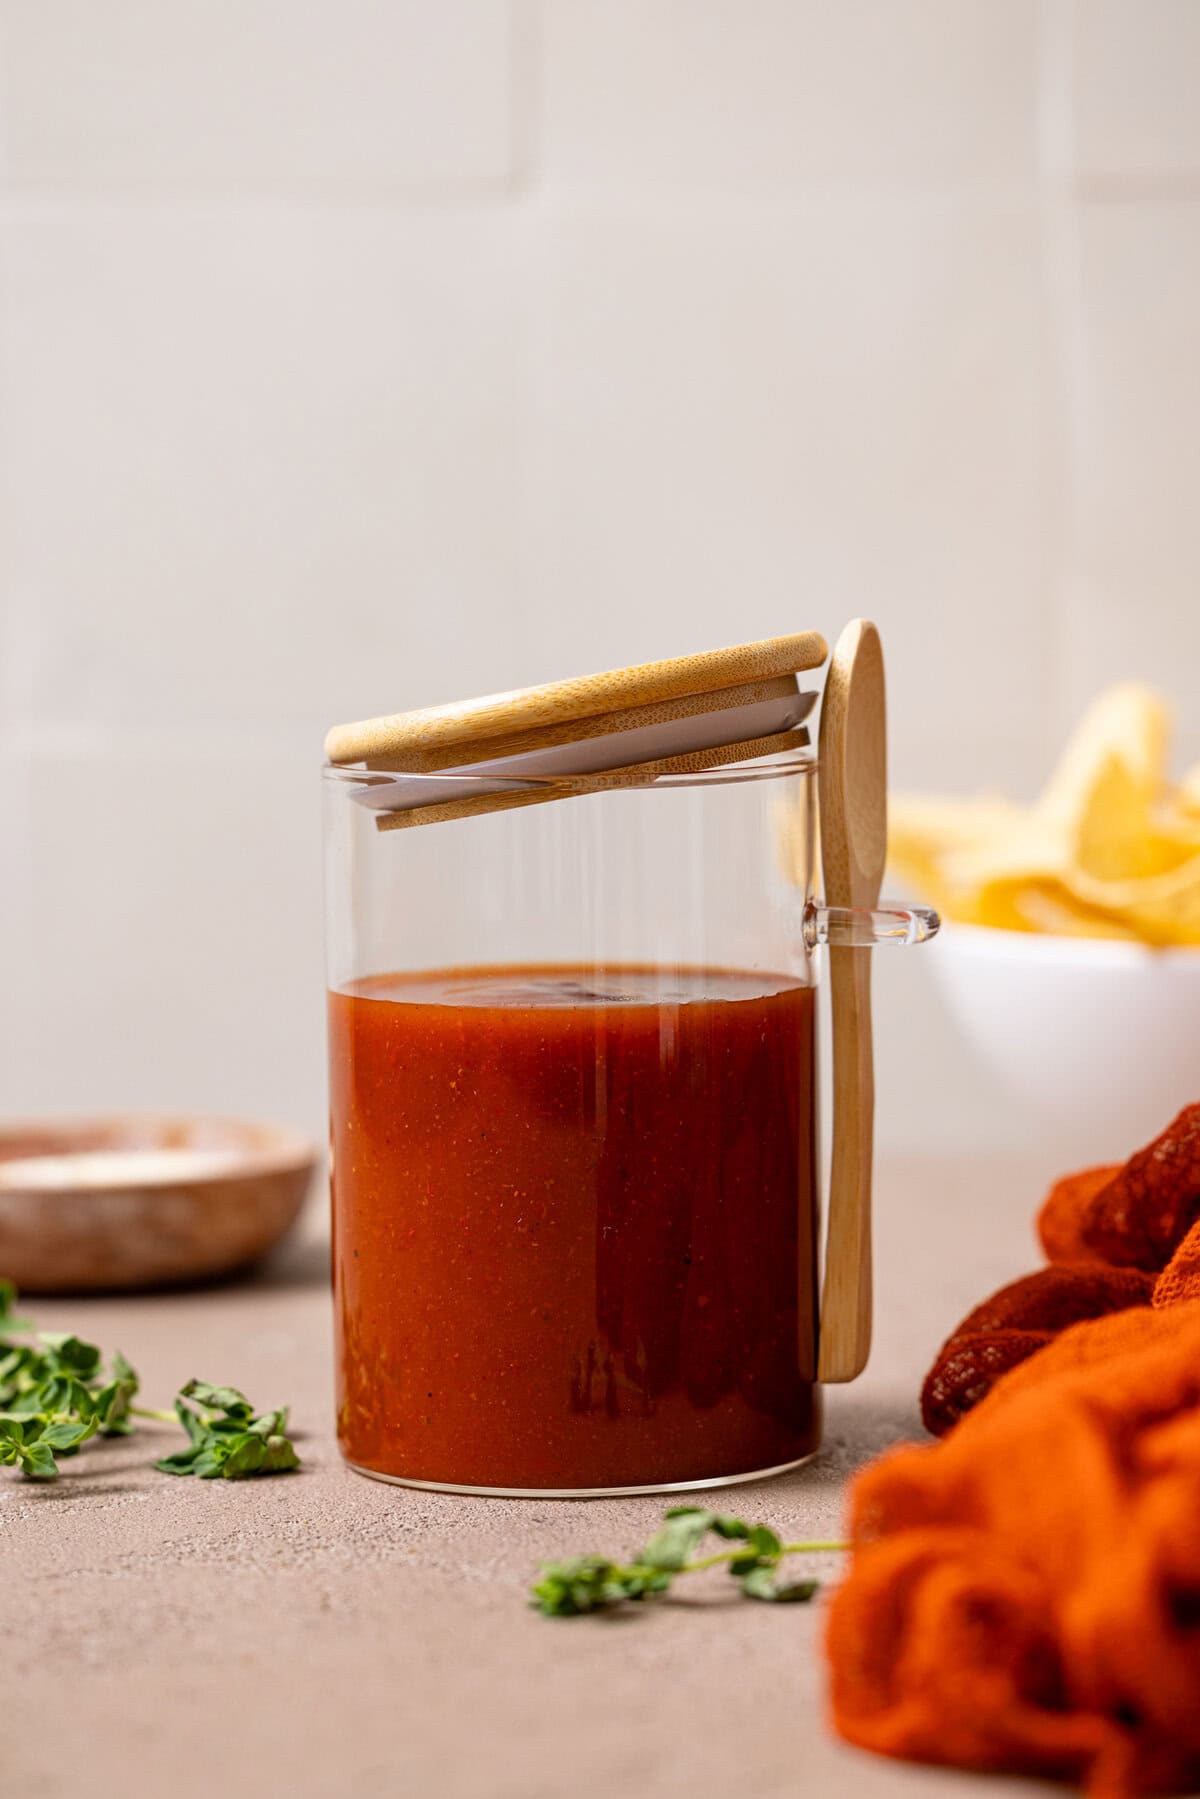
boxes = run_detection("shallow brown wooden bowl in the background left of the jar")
[0,1115,317,1293]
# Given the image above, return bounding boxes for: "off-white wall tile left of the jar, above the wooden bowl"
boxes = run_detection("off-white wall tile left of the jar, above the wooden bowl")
[15,734,324,1126]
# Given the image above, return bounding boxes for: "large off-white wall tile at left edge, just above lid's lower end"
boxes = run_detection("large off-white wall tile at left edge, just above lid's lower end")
[5,200,529,748]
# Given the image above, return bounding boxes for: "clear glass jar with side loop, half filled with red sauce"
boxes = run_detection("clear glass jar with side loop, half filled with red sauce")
[324,752,921,1497]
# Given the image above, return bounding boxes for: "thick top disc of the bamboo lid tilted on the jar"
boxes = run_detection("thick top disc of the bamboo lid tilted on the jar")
[326,631,828,774]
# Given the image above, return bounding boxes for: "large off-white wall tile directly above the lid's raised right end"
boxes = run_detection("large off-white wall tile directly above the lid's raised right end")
[534,191,1047,783]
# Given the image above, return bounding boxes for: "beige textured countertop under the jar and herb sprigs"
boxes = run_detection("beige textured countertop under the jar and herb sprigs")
[0,1162,1061,1799]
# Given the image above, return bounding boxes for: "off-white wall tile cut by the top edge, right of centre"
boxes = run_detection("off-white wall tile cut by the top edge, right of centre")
[543,0,1036,191]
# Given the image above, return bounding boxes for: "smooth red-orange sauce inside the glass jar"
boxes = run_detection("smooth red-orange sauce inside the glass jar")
[329,966,819,1490]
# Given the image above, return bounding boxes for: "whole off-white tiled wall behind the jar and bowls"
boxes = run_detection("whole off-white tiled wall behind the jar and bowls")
[0,0,1200,1148]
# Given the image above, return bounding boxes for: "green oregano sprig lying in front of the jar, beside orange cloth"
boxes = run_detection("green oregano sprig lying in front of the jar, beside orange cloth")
[531,1506,849,1617]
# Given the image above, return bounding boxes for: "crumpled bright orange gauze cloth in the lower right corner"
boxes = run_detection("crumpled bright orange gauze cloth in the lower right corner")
[828,1108,1200,1799]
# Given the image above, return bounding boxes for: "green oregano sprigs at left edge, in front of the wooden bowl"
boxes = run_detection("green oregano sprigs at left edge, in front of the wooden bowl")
[0,1279,300,1481]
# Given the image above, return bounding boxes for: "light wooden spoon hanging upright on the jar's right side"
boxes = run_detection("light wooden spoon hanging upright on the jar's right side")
[817,619,887,1380]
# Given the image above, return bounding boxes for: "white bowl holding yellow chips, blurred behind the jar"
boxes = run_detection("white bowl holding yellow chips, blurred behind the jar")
[930,925,1200,1162]
